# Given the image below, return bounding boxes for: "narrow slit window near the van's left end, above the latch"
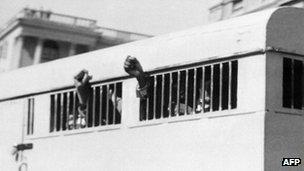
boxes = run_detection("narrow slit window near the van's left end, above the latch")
[26,98,35,135]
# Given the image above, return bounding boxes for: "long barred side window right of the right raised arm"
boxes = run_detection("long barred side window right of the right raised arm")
[139,60,238,121]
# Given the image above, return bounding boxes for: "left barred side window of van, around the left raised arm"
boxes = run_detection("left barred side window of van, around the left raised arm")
[50,82,122,132]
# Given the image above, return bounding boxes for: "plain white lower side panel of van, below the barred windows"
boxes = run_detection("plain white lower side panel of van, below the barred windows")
[27,112,264,171]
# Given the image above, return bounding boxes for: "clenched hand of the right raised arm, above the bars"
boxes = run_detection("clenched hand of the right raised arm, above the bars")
[124,56,144,78]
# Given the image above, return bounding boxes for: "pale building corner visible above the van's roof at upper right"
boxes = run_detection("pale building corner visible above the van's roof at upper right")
[209,0,304,22]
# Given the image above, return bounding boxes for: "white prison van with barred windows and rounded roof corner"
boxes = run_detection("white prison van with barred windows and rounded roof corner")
[0,7,304,171]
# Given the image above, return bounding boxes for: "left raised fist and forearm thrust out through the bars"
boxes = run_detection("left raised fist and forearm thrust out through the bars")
[74,70,92,105]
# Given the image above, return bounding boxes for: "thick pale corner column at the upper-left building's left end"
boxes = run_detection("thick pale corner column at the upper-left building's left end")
[9,36,24,70]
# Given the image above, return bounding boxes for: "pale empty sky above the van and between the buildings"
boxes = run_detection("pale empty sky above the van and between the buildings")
[0,0,212,35]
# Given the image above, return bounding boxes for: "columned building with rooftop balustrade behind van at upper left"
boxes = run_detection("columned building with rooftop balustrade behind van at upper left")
[0,8,151,72]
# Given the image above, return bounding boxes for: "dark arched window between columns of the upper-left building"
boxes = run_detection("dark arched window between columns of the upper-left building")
[41,40,59,63]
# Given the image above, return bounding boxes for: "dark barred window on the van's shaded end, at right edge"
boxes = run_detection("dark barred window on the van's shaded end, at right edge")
[282,58,304,109]
